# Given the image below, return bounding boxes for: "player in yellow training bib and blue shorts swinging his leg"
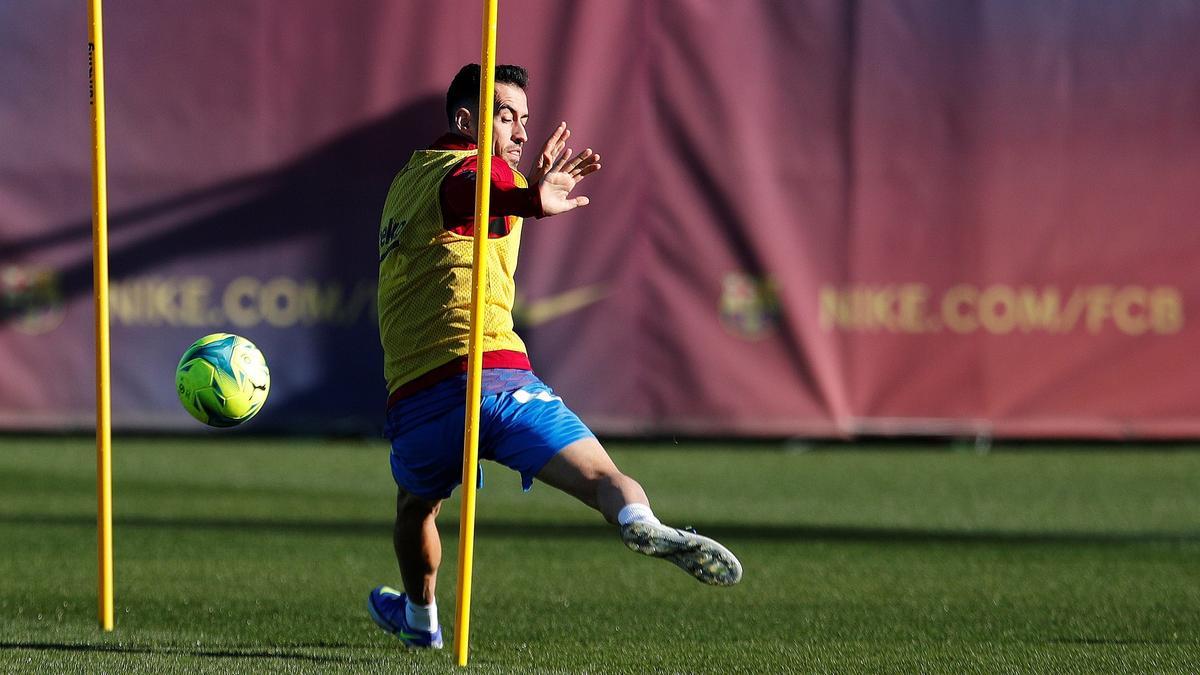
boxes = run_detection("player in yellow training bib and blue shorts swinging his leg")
[367,64,742,649]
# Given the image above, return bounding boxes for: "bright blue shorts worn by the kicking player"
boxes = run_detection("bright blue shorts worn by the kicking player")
[384,370,594,501]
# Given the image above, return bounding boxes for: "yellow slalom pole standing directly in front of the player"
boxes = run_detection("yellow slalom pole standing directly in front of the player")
[454,0,497,665]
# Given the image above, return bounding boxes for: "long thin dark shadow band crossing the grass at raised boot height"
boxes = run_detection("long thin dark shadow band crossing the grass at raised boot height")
[0,514,1200,545]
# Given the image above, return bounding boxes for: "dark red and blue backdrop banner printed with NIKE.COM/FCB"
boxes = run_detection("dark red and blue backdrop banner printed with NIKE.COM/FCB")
[0,0,1200,437]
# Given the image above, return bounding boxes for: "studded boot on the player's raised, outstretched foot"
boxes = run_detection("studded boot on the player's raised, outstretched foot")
[620,522,742,586]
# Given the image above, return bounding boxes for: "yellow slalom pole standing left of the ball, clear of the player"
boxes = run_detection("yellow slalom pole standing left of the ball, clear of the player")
[88,0,113,631]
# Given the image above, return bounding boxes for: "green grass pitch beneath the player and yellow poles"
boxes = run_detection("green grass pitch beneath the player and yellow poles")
[0,434,1200,673]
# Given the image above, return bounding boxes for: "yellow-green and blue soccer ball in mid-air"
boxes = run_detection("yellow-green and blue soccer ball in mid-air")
[175,333,271,426]
